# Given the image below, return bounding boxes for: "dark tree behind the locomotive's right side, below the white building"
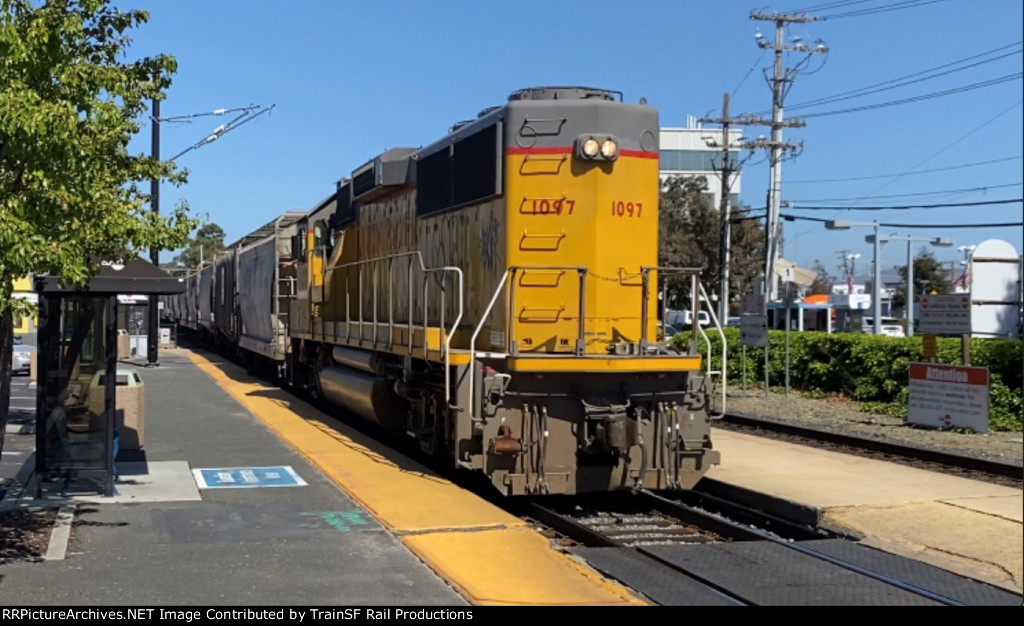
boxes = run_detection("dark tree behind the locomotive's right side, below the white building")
[658,176,764,307]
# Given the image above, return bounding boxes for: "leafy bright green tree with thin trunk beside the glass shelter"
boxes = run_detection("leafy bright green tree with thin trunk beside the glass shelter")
[0,0,196,449]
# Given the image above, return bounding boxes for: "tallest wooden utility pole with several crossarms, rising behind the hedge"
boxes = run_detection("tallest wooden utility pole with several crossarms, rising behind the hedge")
[751,11,828,300]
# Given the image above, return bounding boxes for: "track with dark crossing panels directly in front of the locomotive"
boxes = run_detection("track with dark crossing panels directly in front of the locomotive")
[520,491,1021,606]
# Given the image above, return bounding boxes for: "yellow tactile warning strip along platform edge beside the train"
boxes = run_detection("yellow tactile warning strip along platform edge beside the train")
[189,352,645,606]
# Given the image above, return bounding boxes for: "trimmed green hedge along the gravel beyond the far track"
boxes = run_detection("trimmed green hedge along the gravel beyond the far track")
[673,327,1024,431]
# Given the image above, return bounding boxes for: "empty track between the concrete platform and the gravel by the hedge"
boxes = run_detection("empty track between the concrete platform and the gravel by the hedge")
[717,414,1024,488]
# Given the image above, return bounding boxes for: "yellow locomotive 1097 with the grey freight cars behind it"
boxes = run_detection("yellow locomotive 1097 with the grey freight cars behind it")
[167,87,726,496]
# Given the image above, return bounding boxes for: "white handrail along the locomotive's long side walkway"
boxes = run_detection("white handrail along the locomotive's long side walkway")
[325,250,464,406]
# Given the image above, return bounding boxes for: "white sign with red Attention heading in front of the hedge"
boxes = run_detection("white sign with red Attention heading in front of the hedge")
[906,363,988,432]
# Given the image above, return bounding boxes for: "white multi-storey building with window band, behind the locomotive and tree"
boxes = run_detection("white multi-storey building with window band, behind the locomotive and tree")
[659,116,742,213]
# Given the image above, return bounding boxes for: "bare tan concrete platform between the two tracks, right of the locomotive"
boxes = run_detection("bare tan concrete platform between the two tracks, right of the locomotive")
[698,428,1024,593]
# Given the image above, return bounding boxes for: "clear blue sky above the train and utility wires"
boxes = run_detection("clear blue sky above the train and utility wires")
[118,0,1024,274]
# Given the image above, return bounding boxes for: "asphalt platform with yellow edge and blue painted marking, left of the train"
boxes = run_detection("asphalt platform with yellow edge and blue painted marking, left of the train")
[0,349,644,607]
